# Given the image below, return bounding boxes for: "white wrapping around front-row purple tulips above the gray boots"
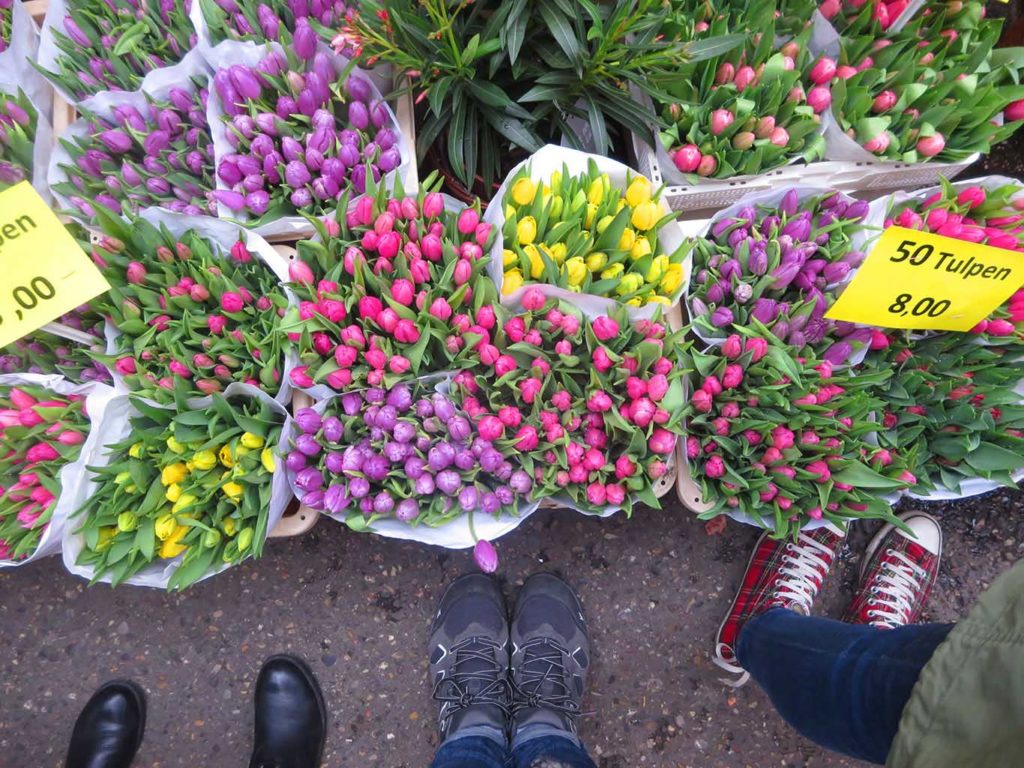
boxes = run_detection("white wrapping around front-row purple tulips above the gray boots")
[279,373,544,549]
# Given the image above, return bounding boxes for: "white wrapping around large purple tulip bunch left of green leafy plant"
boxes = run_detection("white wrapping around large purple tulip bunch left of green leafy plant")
[203,38,419,240]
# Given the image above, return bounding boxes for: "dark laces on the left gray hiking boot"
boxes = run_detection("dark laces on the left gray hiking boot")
[432,637,510,731]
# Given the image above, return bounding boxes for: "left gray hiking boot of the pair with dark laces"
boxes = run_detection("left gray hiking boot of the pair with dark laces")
[430,573,511,741]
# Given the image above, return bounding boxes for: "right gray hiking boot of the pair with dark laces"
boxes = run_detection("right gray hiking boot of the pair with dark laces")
[512,573,590,737]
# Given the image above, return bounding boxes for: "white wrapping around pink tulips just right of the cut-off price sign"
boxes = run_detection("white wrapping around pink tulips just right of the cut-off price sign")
[104,208,298,408]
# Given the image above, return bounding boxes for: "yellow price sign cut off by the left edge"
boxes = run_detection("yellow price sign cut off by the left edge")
[0,181,111,347]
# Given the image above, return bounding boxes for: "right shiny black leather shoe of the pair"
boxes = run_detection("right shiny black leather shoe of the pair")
[249,654,327,768]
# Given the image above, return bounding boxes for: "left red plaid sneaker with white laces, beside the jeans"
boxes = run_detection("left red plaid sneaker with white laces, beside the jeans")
[712,524,846,687]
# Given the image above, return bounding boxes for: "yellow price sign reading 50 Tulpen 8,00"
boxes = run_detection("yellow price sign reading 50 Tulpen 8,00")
[825,226,1024,331]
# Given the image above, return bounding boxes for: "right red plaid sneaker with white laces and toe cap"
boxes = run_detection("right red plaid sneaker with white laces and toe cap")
[843,512,942,629]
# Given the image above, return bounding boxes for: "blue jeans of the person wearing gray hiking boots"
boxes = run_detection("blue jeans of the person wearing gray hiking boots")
[430,726,597,768]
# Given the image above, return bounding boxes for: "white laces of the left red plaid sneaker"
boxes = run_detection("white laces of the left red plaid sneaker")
[711,534,836,688]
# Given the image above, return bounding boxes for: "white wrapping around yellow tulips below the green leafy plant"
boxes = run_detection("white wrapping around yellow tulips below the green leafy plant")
[483,144,693,322]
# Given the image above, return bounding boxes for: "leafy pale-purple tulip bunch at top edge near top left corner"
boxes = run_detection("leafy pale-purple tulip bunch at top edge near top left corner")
[38,0,196,101]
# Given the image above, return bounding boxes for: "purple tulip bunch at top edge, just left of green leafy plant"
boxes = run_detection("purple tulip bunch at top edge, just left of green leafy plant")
[202,0,348,43]
